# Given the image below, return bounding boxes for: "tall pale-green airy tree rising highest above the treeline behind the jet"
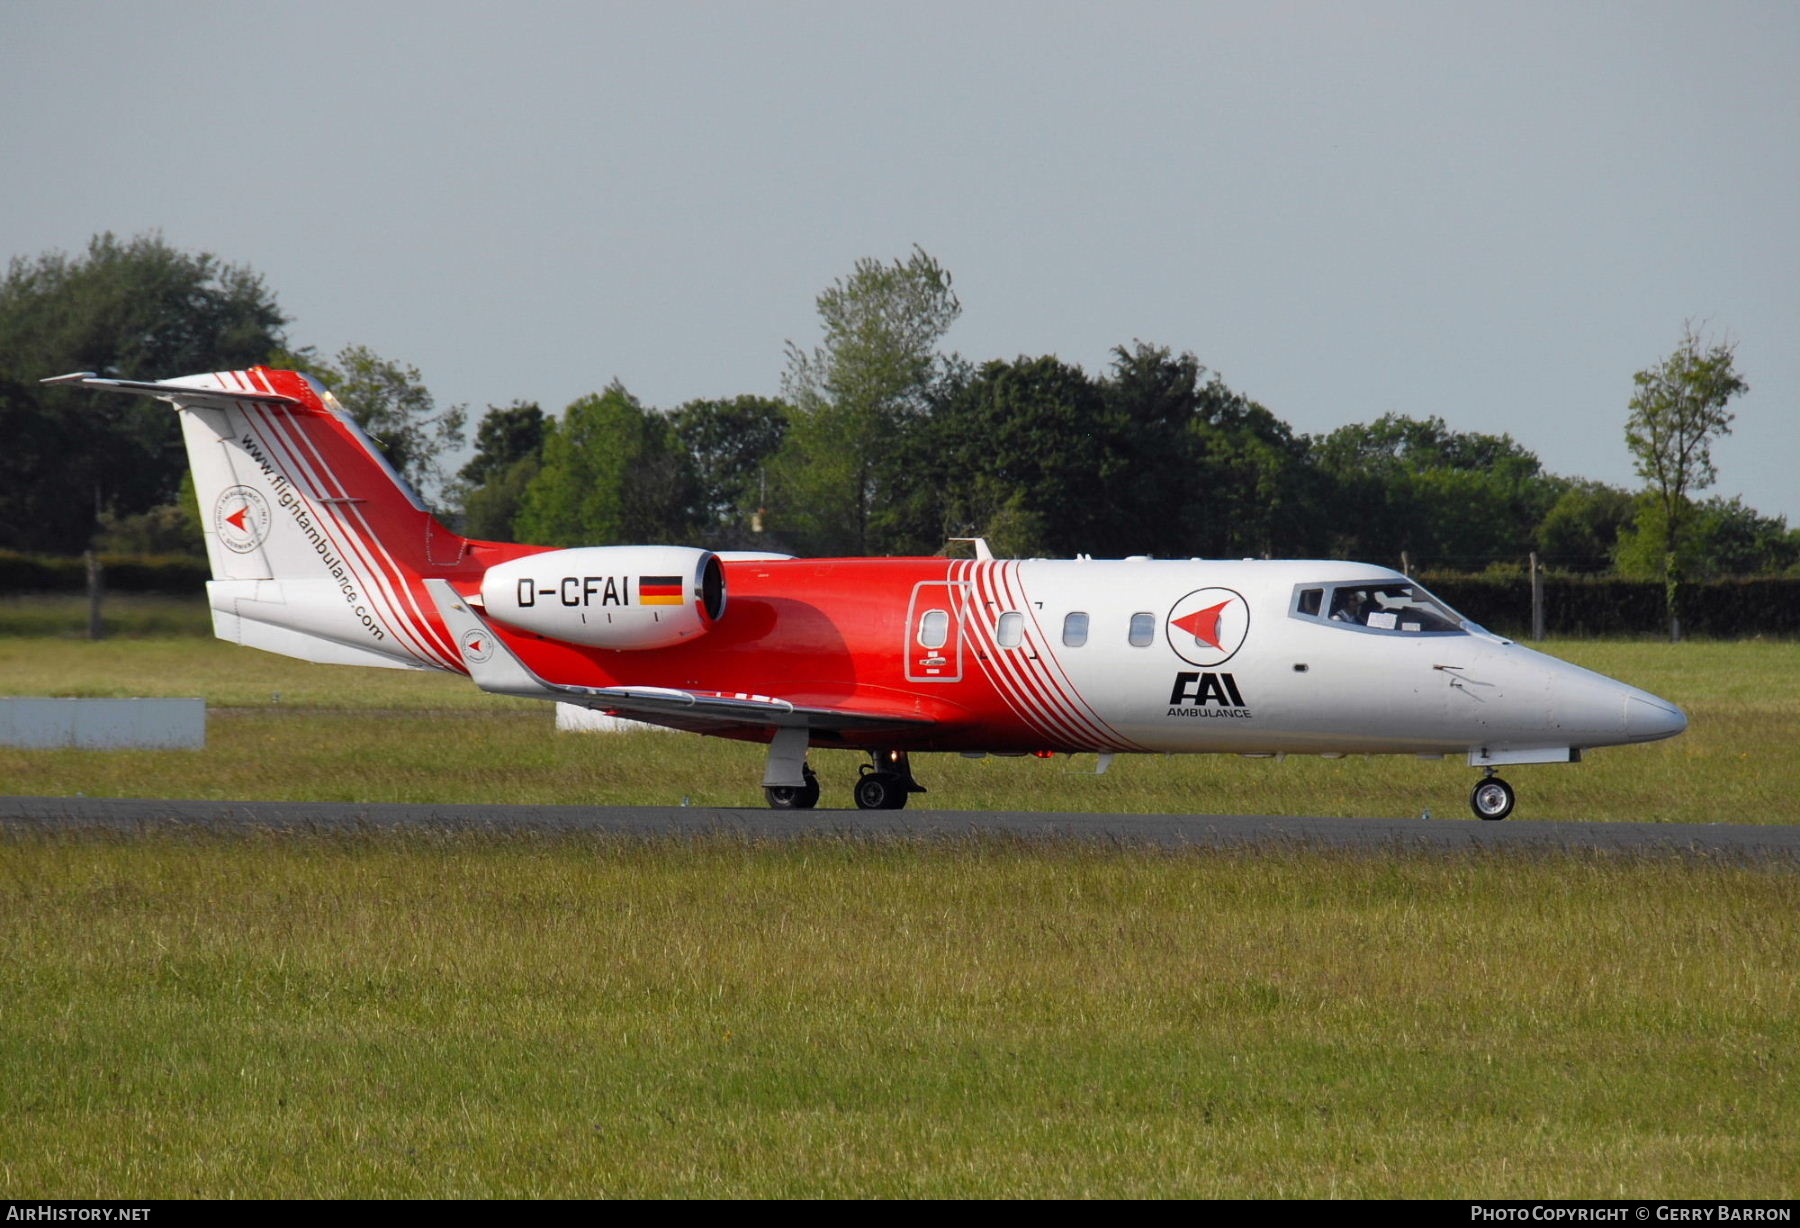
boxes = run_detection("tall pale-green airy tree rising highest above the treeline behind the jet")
[778,247,963,555]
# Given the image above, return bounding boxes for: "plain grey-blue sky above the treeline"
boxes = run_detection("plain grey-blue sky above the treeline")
[0,0,1800,522]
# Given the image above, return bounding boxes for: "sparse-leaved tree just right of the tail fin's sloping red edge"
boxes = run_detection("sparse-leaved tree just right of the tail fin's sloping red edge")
[272,346,468,501]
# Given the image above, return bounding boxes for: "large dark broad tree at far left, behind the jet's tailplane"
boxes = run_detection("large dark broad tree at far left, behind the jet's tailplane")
[0,234,286,551]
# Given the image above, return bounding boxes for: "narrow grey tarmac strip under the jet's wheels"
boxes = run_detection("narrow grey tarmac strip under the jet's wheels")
[0,798,1800,849]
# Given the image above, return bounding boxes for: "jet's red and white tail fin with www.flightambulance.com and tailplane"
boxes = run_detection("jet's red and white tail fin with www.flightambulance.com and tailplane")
[45,367,493,672]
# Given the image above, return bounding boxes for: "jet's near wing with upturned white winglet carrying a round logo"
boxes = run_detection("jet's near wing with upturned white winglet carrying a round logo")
[425,580,936,733]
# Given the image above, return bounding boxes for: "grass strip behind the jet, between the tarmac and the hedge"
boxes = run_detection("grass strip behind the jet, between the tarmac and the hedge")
[0,603,1800,823]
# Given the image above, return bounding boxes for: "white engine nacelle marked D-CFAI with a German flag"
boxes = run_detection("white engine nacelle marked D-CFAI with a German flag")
[481,546,725,648]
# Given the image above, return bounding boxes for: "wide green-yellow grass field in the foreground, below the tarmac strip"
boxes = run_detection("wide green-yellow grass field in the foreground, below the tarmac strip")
[0,832,1800,1199]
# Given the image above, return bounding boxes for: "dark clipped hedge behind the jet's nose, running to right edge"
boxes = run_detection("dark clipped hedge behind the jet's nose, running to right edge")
[1422,574,1800,639]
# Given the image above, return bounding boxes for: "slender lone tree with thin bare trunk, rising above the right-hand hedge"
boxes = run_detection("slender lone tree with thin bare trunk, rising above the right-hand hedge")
[1625,322,1750,641]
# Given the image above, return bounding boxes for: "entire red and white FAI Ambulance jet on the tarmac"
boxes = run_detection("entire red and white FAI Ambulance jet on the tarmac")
[47,367,1687,819]
